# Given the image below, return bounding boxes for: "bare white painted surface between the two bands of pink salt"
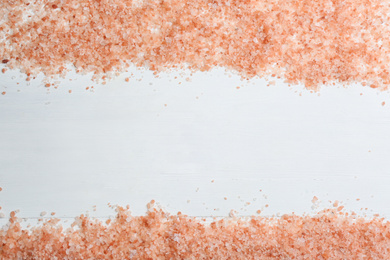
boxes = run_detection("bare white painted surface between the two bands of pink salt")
[0,66,390,223]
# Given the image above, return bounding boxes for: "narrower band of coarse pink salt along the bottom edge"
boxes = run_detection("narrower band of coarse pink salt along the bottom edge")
[0,202,390,259]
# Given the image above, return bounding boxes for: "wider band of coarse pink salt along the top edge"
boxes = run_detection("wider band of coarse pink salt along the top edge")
[0,0,390,89]
